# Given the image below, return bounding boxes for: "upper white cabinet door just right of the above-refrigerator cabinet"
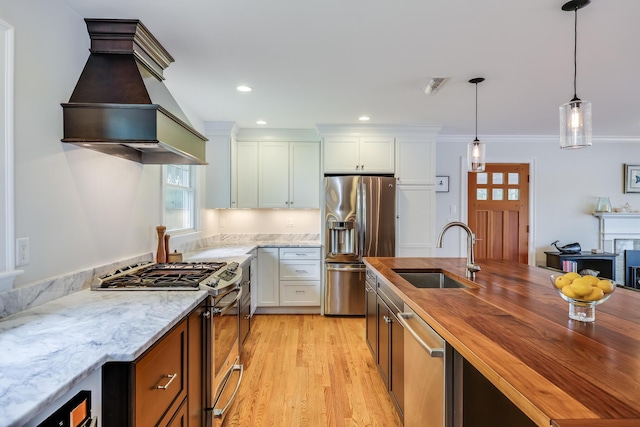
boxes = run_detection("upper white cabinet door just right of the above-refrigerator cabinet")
[396,138,436,185]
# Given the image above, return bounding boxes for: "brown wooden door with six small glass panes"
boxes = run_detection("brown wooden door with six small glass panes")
[467,163,529,264]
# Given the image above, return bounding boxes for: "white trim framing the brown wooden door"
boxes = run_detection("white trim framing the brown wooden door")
[459,156,536,265]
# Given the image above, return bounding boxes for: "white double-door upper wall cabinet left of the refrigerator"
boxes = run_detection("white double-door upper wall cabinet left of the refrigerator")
[258,142,320,209]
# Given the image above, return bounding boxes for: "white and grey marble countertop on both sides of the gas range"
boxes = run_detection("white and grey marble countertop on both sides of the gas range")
[0,241,320,426]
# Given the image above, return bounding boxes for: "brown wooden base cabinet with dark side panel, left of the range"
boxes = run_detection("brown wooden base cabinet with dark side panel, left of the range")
[101,320,188,427]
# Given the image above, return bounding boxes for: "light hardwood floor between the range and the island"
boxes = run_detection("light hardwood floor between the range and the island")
[224,315,402,427]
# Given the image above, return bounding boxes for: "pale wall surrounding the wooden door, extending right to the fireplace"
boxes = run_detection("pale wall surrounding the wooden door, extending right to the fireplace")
[436,136,640,263]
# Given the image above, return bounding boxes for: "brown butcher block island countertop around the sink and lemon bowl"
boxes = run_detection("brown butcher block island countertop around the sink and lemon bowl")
[364,258,640,427]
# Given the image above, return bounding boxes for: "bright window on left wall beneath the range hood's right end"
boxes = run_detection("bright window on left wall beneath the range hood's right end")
[164,165,197,232]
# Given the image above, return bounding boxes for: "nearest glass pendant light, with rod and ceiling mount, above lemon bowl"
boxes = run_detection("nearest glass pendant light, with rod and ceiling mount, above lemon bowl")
[560,0,591,148]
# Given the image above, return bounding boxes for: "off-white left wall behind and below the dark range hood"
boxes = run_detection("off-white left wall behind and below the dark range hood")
[0,0,208,285]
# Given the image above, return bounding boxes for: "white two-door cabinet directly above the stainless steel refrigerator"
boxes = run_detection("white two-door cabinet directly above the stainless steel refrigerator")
[324,137,395,174]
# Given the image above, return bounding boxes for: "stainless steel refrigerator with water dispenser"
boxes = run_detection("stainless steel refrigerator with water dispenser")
[324,175,396,316]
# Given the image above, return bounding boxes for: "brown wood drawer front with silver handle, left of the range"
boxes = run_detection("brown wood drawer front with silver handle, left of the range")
[135,321,187,426]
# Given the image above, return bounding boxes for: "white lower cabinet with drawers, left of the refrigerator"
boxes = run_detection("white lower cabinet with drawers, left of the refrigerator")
[258,248,321,312]
